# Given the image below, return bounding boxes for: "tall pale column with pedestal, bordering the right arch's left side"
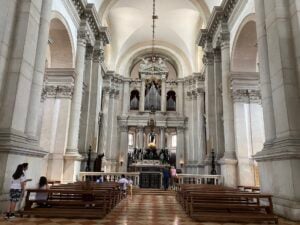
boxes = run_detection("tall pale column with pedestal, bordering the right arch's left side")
[219,23,237,187]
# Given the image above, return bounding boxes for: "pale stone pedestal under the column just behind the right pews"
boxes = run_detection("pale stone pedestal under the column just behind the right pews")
[218,157,237,187]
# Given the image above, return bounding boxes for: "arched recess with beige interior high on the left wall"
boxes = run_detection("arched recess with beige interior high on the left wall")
[46,12,74,68]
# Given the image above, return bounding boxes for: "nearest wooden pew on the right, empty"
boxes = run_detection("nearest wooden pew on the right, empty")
[189,192,278,224]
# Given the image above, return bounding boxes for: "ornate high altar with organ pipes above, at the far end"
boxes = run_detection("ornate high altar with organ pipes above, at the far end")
[119,56,184,188]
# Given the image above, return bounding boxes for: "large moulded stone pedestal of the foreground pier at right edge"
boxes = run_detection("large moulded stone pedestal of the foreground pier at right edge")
[254,139,300,221]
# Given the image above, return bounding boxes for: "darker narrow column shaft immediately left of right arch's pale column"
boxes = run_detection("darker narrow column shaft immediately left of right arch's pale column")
[214,48,224,159]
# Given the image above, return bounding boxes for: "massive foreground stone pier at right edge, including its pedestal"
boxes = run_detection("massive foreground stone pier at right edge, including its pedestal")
[255,0,300,220]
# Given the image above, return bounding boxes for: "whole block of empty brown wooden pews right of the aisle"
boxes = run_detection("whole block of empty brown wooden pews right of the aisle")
[176,184,278,224]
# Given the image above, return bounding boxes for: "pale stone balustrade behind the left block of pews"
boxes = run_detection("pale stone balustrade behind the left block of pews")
[79,172,140,186]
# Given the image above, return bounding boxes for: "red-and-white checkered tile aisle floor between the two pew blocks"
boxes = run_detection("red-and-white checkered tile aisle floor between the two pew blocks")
[101,194,200,225]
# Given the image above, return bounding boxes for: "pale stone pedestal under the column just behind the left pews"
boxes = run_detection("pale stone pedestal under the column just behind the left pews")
[63,153,83,183]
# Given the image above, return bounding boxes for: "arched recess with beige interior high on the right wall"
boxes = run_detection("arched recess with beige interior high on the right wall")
[231,14,257,72]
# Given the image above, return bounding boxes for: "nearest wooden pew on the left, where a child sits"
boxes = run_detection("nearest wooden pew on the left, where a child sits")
[22,189,108,218]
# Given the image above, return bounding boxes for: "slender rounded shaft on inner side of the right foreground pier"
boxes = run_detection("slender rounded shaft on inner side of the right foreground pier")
[255,0,276,144]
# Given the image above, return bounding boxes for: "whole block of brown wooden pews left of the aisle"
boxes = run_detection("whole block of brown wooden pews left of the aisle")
[22,182,124,218]
